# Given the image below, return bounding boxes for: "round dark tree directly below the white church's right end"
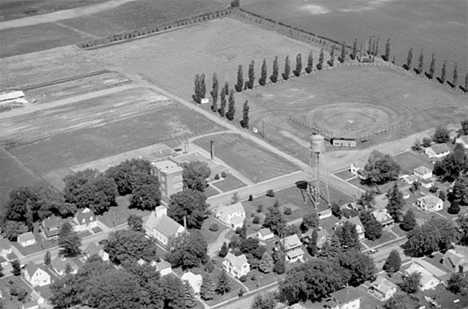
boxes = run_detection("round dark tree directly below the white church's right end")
[166,230,208,269]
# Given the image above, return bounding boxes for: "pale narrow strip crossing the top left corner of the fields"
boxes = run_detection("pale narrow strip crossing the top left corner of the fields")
[0,0,136,30]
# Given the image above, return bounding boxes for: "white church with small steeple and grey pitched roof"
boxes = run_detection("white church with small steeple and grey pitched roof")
[143,206,187,247]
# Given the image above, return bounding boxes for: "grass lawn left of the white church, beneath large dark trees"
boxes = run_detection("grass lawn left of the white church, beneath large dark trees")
[98,195,151,228]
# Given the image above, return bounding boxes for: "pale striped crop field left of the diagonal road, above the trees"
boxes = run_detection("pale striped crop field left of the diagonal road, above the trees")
[2,88,225,175]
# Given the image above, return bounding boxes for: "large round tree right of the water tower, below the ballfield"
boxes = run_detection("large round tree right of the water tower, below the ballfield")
[362,150,401,187]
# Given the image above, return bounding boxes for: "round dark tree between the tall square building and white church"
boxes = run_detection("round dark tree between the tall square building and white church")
[167,189,206,229]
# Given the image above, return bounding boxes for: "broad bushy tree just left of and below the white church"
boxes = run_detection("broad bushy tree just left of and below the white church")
[104,230,158,265]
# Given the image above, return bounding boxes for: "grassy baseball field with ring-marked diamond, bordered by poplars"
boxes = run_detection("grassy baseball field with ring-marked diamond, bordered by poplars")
[234,66,468,162]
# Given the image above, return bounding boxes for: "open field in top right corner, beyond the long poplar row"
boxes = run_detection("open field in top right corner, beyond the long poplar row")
[242,0,468,74]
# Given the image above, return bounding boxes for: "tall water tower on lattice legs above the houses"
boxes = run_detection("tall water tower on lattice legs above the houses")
[309,135,330,208]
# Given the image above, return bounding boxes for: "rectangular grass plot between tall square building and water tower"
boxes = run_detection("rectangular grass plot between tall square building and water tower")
[195,134,298,182]
